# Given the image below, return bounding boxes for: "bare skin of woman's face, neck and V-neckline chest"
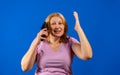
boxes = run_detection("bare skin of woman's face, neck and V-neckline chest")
[48,16,64,51]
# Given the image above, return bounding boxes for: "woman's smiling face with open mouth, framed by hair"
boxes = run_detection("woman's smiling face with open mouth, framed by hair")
[50,16,65,37]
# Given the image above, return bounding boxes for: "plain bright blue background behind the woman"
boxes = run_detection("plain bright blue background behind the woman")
[0,0,120,75]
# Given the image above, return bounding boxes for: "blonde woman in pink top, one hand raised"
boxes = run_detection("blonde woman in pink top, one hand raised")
[21,12,92,75]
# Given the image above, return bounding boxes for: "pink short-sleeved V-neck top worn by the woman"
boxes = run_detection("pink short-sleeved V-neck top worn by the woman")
[35,37,78,75]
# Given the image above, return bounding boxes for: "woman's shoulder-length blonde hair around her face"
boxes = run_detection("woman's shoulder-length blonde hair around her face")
[45,12,68,43]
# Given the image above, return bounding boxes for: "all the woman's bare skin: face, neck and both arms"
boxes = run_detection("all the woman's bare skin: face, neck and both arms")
[21,12,92,71]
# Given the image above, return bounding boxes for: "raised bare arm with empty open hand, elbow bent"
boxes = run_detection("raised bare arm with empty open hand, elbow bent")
[72,12,92,60]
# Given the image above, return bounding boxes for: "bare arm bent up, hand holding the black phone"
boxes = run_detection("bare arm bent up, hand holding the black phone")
[21,29,47,71]
